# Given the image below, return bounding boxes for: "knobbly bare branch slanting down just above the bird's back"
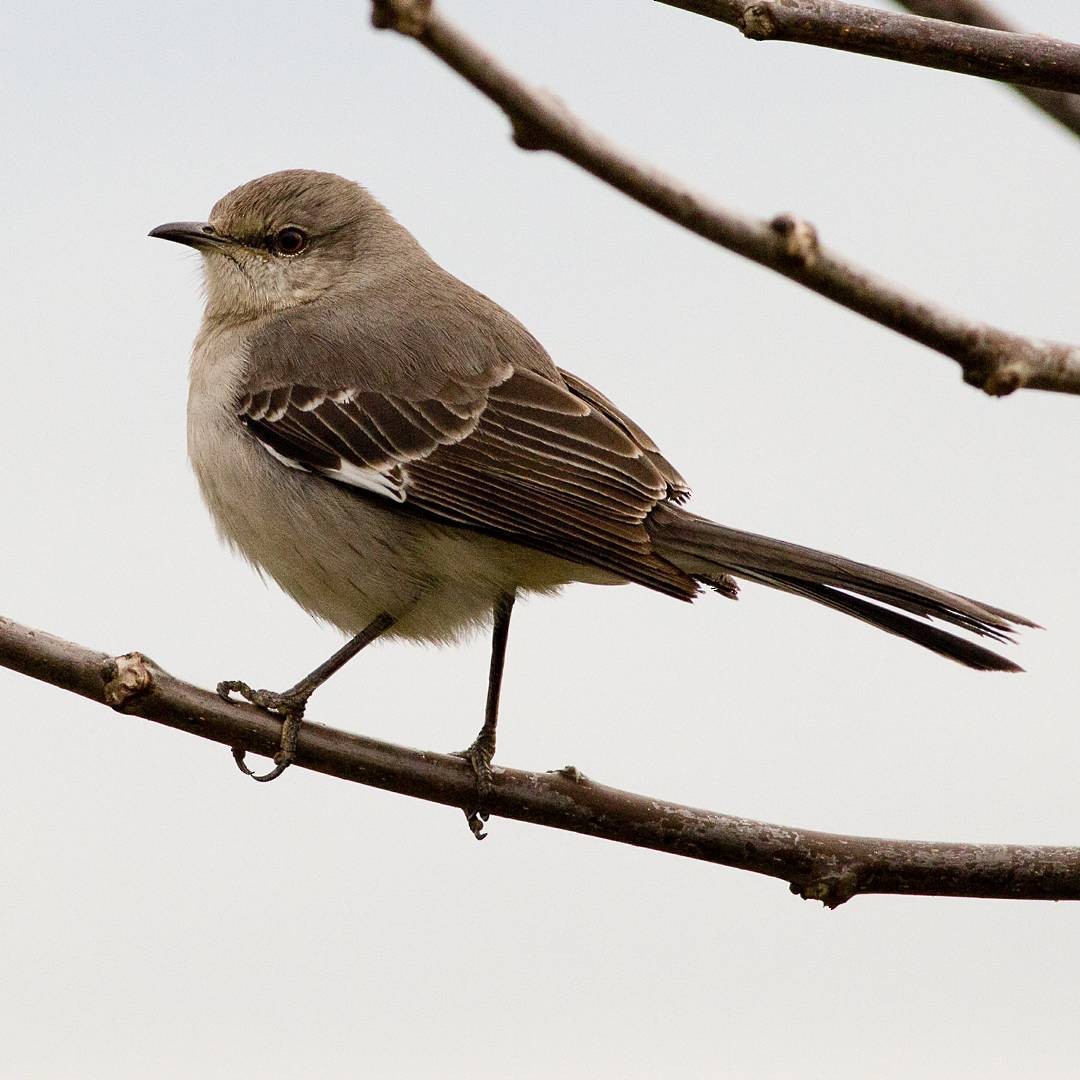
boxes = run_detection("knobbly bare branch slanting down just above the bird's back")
[373,0,1080,396]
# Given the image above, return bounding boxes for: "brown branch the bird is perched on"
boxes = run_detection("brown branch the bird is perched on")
[0,618,1080,907]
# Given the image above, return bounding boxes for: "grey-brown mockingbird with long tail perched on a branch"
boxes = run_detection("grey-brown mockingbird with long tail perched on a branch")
[150,170,1034,816]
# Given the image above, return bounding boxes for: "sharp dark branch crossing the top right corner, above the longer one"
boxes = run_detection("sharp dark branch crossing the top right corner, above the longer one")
[660,0,1080,93]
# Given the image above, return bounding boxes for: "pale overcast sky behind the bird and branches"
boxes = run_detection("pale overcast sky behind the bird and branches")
[0,0,1080,1080]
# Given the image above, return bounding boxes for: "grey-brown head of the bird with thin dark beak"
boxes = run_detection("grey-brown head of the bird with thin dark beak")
[150,168,408,321]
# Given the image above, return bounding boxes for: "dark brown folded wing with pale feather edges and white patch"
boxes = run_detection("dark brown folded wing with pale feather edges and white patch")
[237,363,698,599]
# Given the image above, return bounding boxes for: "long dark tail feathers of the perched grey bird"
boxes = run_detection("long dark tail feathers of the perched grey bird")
[648,507,1038,672]
